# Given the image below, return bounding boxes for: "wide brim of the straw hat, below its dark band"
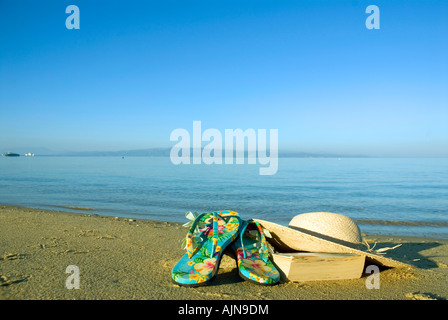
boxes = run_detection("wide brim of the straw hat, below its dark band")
[254,219,413,268]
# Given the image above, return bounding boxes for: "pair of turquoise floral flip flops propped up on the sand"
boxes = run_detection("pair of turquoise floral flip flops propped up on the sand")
[171,210,280,287]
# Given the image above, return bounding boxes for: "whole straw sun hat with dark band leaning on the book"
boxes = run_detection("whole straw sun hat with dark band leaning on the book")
[255,212,412,267]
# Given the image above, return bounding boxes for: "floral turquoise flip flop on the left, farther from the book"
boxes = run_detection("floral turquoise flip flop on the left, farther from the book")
[171,210,241,287]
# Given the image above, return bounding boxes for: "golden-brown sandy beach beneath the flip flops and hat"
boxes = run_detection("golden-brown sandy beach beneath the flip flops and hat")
[0,205,448,300]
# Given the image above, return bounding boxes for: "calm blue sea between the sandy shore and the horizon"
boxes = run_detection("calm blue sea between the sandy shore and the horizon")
[0,156,448,238]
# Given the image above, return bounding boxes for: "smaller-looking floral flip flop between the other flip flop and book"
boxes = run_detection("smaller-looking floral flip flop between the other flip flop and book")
[232,220,280,285]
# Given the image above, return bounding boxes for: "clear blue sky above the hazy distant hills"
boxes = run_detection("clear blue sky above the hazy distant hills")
[0,0,448,156]
